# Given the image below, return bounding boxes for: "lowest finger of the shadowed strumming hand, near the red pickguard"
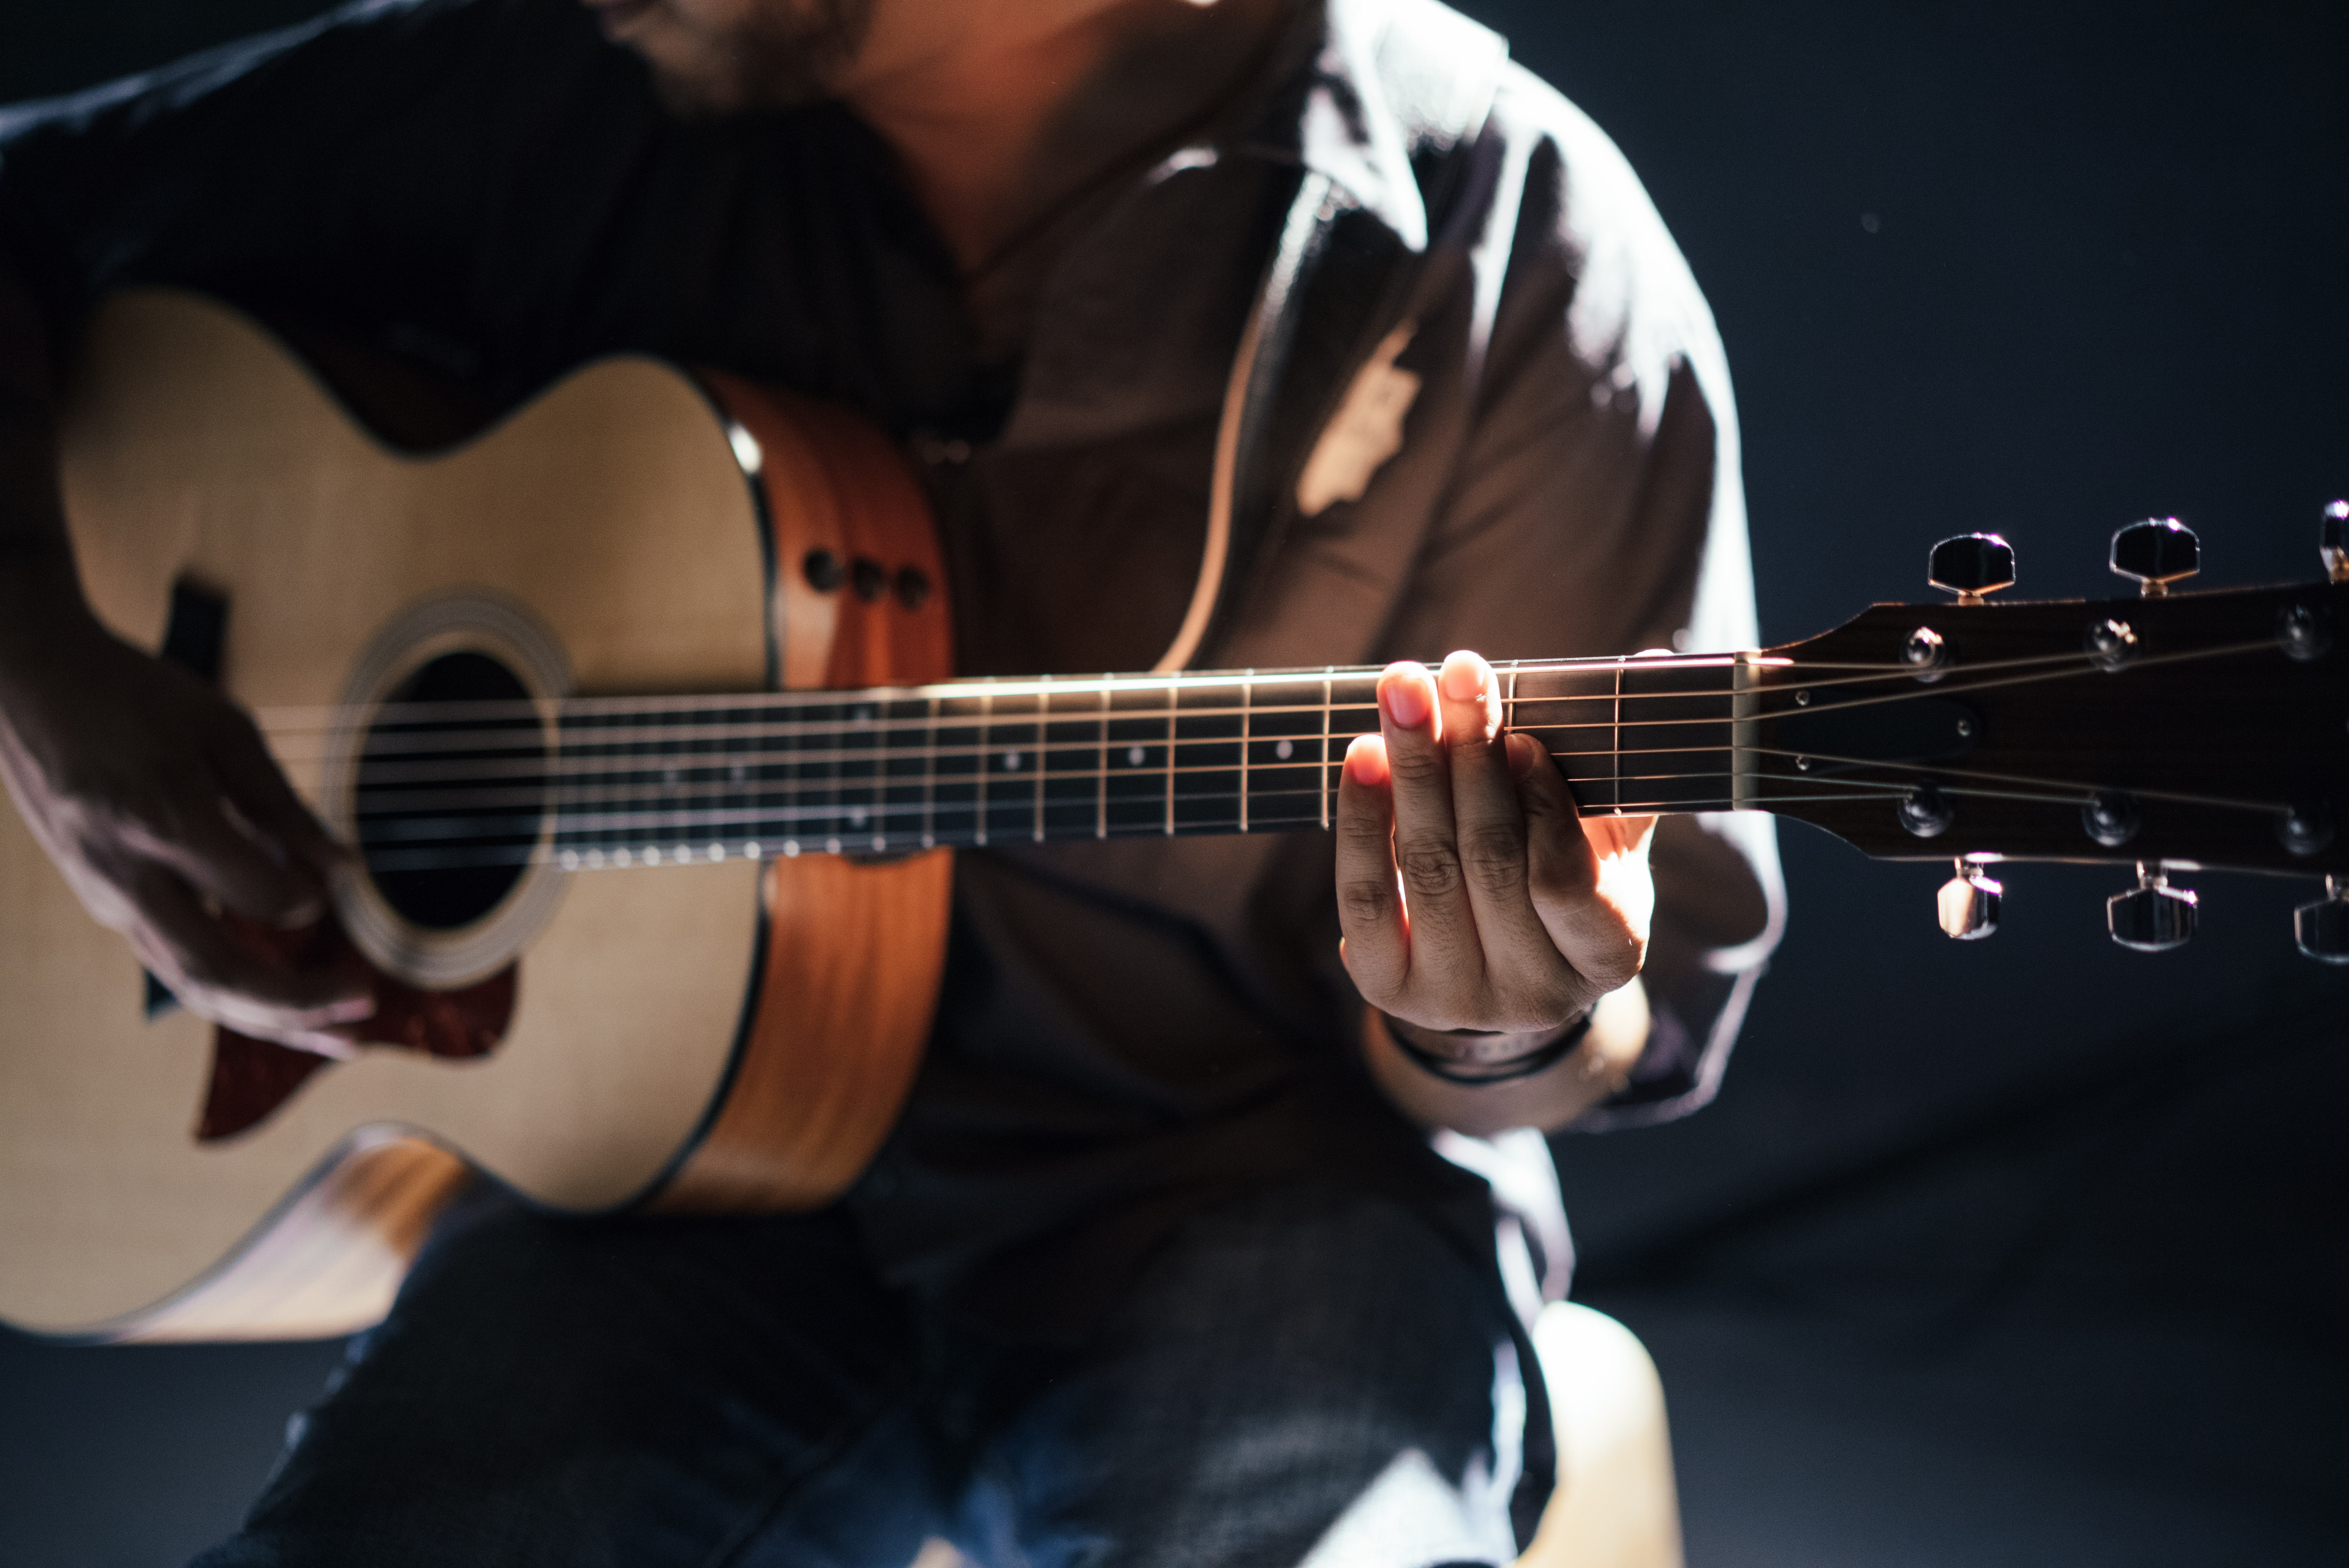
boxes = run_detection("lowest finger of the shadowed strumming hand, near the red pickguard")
[129,866,376,1056]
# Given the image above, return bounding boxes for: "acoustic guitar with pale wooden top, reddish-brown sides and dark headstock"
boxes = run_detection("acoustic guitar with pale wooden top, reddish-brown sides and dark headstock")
[0,291,2349,1338]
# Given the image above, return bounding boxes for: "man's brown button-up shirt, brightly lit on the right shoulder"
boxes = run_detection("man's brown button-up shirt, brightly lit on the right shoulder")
[0,0,1778,1329]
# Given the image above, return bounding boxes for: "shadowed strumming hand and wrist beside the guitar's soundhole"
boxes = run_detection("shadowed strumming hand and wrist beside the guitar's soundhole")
[0,575,374,1056]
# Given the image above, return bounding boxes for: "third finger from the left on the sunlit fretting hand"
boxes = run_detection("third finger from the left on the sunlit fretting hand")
[1435,652,1579,1030]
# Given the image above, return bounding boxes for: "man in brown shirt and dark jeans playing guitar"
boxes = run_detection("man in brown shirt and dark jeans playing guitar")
[0,0,1776,1568]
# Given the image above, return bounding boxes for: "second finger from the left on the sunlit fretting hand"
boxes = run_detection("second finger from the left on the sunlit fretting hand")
[1379,664,1484,991]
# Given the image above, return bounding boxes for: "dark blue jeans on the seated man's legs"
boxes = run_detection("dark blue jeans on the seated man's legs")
[197,1192,1548,1568]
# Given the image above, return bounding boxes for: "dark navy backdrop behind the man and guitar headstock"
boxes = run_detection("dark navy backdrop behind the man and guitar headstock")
[0,0,2349,1568]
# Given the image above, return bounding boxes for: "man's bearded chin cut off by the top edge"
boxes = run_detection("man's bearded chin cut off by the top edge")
[637,0,874,120]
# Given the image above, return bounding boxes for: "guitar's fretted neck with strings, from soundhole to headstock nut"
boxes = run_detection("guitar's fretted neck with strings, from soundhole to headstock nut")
[343,655,1748,871]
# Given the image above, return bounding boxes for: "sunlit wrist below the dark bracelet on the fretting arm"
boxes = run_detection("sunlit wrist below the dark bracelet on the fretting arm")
[1363,979,1649,1138]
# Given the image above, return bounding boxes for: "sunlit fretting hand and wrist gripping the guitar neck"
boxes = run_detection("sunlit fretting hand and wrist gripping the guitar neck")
[1337,652,1656,1131]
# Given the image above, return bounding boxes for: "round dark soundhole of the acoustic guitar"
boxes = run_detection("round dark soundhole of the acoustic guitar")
[355,652,550,932]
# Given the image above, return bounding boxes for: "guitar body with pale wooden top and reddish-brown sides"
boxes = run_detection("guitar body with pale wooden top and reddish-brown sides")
[0,293,951,1338]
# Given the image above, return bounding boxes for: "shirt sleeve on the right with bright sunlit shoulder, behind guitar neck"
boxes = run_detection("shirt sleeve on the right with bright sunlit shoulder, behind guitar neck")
[1393,68,1785,1129]
